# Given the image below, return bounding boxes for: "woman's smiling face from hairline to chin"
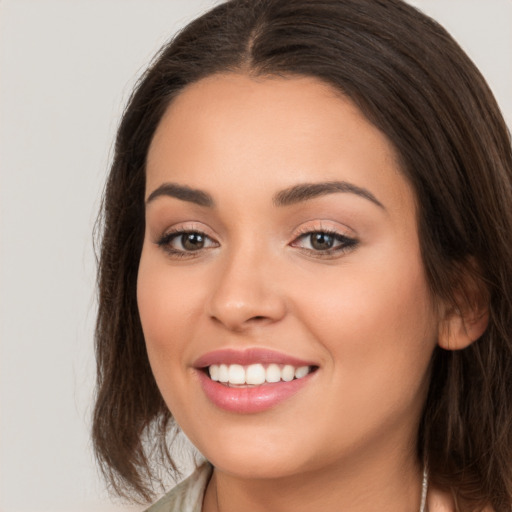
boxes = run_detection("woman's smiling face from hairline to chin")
[138,74,438,477]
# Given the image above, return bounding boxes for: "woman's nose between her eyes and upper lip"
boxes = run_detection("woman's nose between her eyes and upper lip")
[209,245,286,331]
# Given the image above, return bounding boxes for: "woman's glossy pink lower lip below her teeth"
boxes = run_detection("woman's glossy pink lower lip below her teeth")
[197,370,315,414]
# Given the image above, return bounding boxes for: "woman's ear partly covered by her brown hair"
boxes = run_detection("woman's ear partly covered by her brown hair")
[438,266,489,350]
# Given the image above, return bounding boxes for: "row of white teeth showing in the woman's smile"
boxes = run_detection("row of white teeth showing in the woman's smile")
[209,363,311,386]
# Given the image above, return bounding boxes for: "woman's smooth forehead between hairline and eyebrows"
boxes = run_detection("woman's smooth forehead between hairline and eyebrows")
[146,73,412,214]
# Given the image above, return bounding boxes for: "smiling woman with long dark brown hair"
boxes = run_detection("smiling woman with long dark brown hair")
[94,0,512,512]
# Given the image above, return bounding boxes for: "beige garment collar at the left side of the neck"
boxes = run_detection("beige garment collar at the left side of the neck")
[145,462,213,512]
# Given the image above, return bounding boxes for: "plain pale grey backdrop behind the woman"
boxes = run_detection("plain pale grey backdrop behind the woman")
[0,0,512,512]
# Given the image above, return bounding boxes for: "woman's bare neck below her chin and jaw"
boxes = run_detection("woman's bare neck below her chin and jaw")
[203,444,423,512]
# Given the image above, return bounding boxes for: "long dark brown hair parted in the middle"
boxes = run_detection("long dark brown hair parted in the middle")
[93,0,512,512]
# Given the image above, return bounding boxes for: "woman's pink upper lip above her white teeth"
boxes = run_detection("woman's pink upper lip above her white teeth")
[193,347,315,368]
